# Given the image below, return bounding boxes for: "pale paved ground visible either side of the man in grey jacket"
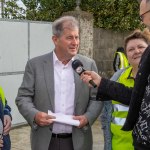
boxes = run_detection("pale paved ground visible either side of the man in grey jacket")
[10,121,103,150]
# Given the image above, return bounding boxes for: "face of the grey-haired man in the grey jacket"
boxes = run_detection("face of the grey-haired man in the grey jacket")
[53,28,79,61]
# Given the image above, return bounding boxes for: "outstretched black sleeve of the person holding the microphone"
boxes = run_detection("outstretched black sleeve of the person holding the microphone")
[97,78,132,105]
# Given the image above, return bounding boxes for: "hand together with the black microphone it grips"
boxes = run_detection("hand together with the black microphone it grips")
[72,59,101,88]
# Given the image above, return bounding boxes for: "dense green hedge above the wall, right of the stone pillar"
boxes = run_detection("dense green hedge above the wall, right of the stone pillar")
[81,0,142,31]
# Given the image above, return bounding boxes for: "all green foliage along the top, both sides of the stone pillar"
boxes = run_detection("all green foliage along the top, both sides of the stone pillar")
[4,0,144,31]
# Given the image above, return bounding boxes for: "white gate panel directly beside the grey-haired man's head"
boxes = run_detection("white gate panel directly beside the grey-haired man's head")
[30,23,54,58]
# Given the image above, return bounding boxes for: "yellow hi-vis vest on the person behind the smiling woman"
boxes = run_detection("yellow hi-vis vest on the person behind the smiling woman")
[116,52,129,69]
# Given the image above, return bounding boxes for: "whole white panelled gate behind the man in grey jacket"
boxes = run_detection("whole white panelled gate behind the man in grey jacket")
[0,19,54,126]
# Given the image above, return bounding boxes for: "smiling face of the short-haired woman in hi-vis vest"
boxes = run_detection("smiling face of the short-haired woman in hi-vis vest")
[126,39,148,68]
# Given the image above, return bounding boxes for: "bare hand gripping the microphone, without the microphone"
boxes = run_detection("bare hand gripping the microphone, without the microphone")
[81,71,101,87]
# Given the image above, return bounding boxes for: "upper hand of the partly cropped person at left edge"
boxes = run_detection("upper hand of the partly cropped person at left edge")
[3,115,11,135]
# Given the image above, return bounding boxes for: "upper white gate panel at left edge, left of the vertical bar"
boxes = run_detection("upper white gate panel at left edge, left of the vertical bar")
[0,21,28,72]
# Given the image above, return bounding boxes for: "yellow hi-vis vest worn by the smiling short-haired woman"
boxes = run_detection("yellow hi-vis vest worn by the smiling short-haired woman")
[111,67,134,150]
